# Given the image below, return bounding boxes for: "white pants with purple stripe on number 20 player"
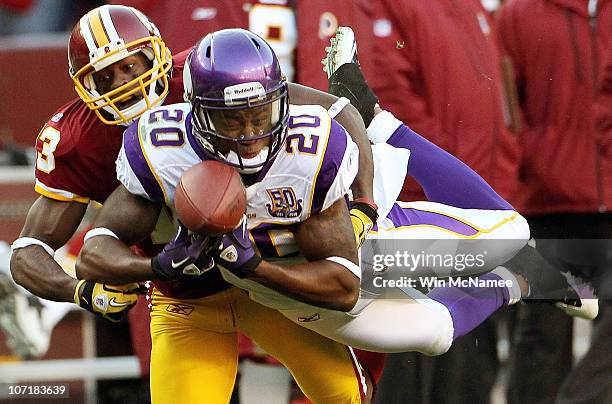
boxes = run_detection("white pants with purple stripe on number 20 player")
[222,202,529,355]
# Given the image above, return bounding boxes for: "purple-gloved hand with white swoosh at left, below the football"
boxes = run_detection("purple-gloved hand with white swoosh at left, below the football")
[151,222,219,281]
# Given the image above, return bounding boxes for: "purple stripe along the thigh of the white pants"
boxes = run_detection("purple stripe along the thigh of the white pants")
[387,204,478,236]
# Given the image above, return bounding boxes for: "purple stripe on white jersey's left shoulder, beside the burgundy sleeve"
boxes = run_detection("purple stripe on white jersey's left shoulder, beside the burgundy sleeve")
[123,121,166,205]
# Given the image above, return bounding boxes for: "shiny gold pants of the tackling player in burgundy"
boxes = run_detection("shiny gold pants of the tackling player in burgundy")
[151,287,362,404]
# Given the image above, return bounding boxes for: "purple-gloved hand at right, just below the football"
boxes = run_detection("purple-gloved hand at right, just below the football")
[216,216,261,278]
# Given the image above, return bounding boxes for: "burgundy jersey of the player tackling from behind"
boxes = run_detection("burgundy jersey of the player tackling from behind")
[35,49,190,203]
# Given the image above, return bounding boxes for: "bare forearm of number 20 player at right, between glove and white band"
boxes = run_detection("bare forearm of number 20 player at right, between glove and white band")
[249,260,360,311]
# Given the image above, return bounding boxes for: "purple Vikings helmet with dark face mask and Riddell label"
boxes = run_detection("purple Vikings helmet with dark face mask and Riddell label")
[183,29,289,174]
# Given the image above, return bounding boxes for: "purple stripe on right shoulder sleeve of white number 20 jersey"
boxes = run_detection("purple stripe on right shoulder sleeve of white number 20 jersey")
[310,119,348,215]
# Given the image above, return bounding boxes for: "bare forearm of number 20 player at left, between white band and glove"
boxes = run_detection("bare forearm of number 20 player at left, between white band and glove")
[76,236,154,284]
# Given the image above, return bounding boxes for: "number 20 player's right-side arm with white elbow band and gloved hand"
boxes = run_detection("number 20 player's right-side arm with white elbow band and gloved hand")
[218,198,361,311]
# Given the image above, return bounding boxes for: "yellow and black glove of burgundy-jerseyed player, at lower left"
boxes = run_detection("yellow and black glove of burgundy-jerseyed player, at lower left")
[74,280,147,323]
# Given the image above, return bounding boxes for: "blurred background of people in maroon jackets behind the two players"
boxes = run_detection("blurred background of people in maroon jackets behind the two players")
[0,0,612,404]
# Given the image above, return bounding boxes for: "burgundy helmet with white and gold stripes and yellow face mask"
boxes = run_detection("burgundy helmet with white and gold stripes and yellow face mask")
[68,5,172,125]
